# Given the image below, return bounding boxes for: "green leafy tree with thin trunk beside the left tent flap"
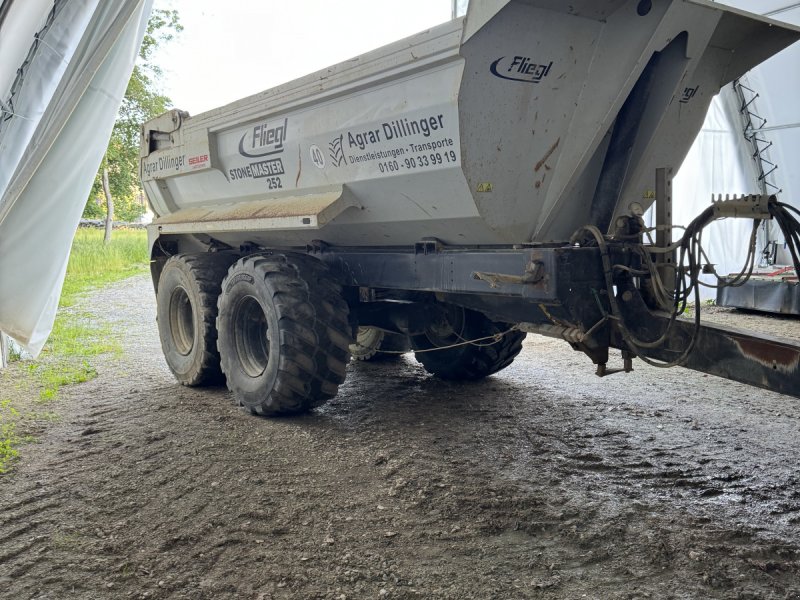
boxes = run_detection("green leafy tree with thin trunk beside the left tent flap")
[83,9,183,243]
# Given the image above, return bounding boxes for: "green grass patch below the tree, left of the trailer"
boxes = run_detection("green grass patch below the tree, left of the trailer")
[0,229,148,474]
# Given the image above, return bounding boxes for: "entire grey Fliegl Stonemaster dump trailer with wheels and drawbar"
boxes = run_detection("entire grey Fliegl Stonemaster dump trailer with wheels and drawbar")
[141,0,800,415]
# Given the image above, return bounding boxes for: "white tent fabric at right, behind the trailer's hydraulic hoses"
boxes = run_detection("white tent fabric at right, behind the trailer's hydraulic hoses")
[673,0,800,298]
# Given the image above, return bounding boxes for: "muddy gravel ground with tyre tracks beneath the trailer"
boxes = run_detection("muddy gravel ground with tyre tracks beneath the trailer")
[0,277,800,600]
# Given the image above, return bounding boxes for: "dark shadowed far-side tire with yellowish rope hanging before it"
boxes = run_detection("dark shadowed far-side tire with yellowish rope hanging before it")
[411,306,525,381]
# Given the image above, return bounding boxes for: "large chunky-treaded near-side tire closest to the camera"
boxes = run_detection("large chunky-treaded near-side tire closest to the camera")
[217,253,353,416]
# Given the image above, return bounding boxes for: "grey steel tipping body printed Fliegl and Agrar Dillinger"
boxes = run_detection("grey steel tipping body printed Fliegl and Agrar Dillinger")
[141,0,798,251]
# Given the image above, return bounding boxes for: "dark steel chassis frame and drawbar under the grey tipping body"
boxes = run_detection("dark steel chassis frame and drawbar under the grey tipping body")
[306,240,800,397]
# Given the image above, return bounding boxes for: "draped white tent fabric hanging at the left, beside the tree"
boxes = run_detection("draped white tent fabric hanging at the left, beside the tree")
[0,0,152,356]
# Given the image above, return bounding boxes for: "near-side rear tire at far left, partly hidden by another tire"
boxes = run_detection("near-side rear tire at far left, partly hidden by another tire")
[156,254,234,386]
